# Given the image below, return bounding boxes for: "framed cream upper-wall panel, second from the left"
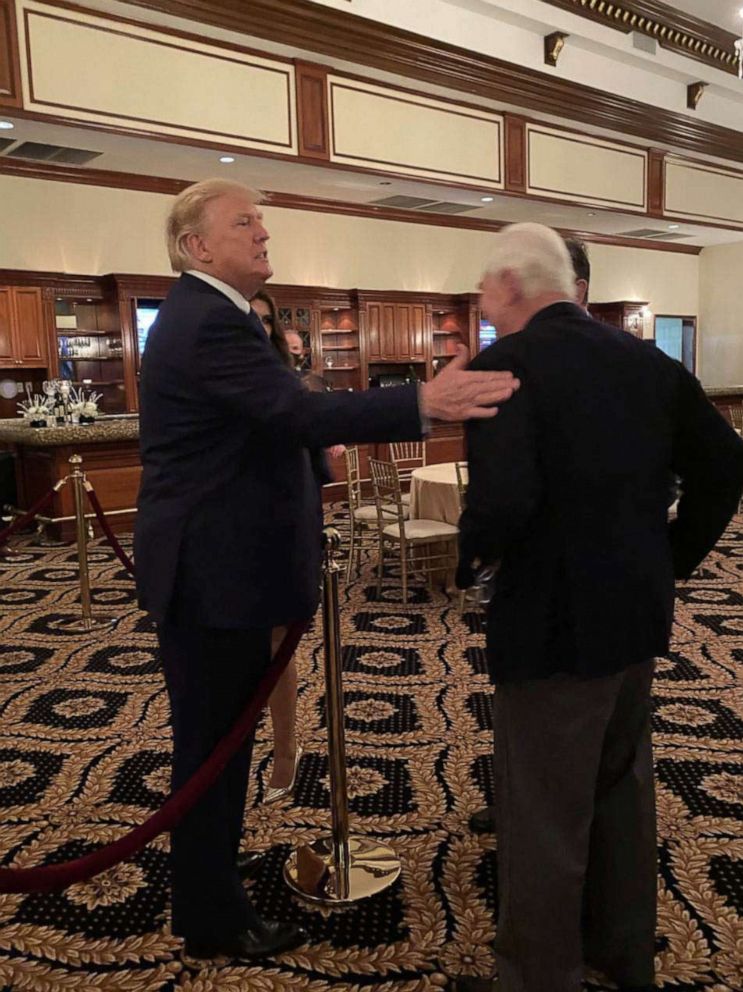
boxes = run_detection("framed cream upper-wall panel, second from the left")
[328,76,503,188]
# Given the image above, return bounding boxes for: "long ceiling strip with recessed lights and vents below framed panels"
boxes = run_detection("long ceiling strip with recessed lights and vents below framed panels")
[0,115,743,247]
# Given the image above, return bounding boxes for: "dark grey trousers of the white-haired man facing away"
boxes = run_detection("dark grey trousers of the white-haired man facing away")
[494,661,657,992]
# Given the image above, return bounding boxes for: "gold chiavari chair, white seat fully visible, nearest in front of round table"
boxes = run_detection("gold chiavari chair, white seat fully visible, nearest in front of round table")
[369,458,459,604]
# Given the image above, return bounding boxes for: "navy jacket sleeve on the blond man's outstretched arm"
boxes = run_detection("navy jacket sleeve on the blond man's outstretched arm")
[195,304,421,448]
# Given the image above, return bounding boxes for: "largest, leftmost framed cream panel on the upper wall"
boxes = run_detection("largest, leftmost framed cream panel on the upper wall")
[20,0,296,154]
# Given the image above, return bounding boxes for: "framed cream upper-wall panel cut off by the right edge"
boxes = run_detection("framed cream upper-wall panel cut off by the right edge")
[665,158,743,225]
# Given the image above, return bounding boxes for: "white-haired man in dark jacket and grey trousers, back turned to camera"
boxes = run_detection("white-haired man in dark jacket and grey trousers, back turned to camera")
[455,224,743,992]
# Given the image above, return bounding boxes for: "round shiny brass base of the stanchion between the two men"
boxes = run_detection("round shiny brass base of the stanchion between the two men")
[284,834,400,906]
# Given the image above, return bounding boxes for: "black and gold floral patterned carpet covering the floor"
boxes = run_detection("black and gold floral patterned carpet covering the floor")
[0,518,743,992]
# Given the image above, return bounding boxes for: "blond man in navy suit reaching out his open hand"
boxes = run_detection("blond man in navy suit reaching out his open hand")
[135,180,517,959]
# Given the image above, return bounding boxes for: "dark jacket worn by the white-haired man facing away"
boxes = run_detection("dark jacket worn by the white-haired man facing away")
[460,303,743,681]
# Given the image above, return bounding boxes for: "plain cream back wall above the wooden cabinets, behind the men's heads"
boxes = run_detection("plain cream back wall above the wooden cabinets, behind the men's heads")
[0,175,700,360]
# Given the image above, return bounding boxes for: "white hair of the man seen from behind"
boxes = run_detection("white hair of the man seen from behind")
[485,224,575,300]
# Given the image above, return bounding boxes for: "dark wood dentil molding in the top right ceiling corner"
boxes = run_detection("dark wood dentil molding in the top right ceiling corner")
[546,0,738,73]
